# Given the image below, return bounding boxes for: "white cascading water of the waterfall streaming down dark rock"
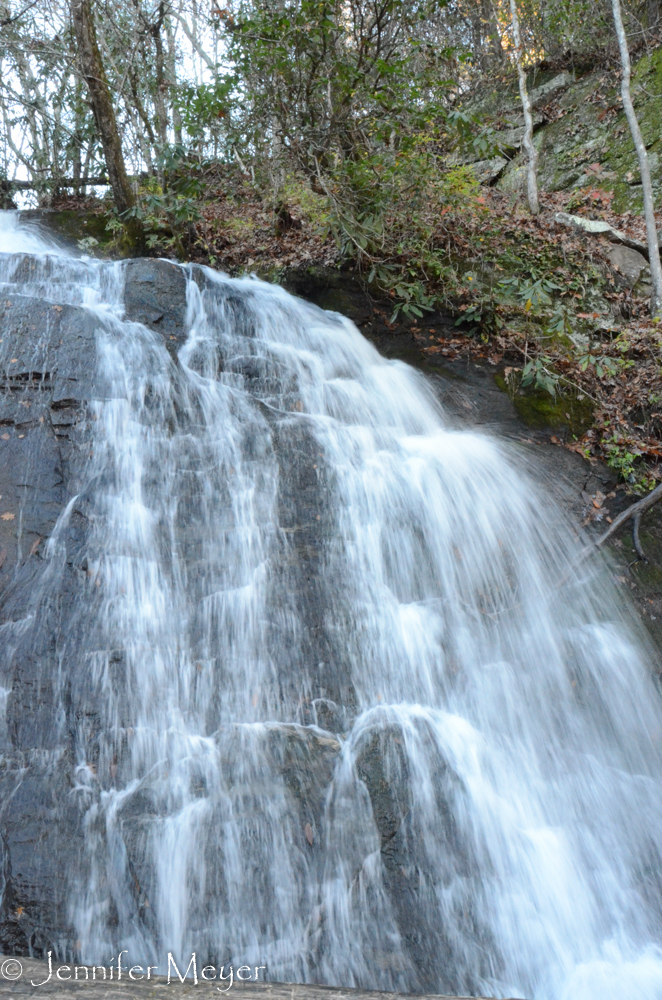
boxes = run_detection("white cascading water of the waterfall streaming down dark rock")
[0,216,662,1000]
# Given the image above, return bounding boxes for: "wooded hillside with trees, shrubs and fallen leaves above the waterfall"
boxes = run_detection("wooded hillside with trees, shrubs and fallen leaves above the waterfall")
[0,0,662,492]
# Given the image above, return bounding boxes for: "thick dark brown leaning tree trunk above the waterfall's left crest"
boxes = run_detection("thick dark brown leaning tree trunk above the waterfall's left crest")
[71,0,136,215]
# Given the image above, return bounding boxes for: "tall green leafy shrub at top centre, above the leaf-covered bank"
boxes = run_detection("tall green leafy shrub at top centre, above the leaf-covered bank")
[223,0,478,320]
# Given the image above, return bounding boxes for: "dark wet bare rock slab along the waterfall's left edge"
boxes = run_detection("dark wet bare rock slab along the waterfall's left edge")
[0,258,99,954]
